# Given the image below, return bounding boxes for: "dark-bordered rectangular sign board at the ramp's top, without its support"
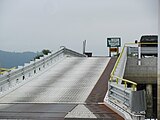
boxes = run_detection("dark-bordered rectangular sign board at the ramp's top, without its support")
[107,37,121,47]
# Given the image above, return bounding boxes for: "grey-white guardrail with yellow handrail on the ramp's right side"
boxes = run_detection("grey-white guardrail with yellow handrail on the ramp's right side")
[104,45,145,120]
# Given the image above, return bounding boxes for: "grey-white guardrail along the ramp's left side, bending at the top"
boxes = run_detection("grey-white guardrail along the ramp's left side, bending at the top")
[0,47,86,94]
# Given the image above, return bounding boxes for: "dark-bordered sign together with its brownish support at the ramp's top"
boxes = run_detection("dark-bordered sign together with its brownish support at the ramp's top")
[107,37,121,57]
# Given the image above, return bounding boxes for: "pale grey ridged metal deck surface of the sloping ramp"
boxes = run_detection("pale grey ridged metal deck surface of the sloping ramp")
[0,57,109,103]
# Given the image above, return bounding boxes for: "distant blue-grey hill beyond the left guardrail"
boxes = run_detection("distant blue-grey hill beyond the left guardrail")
[0,50,37,68]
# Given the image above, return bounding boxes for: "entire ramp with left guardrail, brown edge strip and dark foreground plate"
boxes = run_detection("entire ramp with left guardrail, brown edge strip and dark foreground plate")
[0,47,123,120]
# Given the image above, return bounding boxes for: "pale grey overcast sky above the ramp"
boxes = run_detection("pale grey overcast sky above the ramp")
[0,0,158,55]
